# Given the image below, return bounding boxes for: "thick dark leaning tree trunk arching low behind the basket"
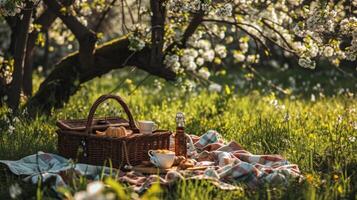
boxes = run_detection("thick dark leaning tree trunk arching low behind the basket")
[26,37,176,114]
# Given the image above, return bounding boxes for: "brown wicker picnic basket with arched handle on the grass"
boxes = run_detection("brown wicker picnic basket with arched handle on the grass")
[57,95,171,168]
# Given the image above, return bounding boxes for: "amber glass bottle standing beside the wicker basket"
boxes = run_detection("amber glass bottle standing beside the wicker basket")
[175,112,187,158]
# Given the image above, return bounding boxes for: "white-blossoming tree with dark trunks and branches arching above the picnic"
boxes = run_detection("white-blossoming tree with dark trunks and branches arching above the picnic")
[0,0,357,111]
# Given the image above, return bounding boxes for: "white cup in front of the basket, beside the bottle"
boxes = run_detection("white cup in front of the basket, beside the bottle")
[148,150,175,169]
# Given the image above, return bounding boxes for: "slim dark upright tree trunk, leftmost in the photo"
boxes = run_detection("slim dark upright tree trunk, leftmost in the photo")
[8,2,33,110]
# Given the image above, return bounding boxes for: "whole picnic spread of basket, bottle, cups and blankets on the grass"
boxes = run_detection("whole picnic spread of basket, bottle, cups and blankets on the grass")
[0,95,302,193]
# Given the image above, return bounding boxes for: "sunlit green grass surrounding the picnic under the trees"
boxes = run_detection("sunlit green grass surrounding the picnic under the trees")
[0,66,357,199]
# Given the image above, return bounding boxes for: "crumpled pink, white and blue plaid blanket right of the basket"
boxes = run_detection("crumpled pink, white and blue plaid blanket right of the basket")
[119,130,302,192]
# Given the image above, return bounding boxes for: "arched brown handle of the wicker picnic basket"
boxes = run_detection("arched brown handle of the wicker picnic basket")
[86,94,140,134]
